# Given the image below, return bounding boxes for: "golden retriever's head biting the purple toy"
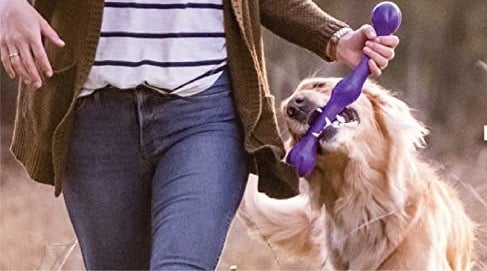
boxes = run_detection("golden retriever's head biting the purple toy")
[281,78,427,160]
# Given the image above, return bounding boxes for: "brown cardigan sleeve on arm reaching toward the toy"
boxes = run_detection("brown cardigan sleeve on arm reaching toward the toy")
[260,0,348,61]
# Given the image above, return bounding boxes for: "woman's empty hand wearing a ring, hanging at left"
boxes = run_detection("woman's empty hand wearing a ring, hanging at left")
[0,0,64,88]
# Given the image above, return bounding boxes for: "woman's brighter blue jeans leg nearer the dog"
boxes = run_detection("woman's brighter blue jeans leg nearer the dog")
[147,71,248,270]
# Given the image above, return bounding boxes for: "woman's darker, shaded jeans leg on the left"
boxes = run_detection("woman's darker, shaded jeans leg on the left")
[63,89,153,270]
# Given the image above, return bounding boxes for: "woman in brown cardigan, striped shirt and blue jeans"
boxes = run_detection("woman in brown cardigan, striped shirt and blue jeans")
[0,0,398,269]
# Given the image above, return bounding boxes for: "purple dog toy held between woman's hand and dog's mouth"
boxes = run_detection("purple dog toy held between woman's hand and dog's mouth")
[287,2,401,177]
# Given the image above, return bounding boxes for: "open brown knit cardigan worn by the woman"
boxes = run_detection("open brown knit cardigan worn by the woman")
[11,0,346,198]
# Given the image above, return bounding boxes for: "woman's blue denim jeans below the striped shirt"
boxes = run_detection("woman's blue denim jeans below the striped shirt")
[63,73,248,270]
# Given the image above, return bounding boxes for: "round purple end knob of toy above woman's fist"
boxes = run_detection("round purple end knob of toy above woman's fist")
[371,1,402,36]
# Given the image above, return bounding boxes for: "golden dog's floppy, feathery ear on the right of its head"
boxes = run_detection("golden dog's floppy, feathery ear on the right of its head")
[364,81,429,152]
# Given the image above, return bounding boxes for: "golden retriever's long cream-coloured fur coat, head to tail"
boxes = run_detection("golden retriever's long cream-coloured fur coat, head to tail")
[239,78,474,270]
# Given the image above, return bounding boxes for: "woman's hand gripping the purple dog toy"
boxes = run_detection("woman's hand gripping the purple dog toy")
[336,25,399,76]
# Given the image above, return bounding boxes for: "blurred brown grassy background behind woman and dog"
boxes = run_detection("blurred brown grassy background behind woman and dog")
[0,0,487,270]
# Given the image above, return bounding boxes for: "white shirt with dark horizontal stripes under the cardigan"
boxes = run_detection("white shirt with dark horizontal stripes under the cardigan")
[80,0,227,96]
